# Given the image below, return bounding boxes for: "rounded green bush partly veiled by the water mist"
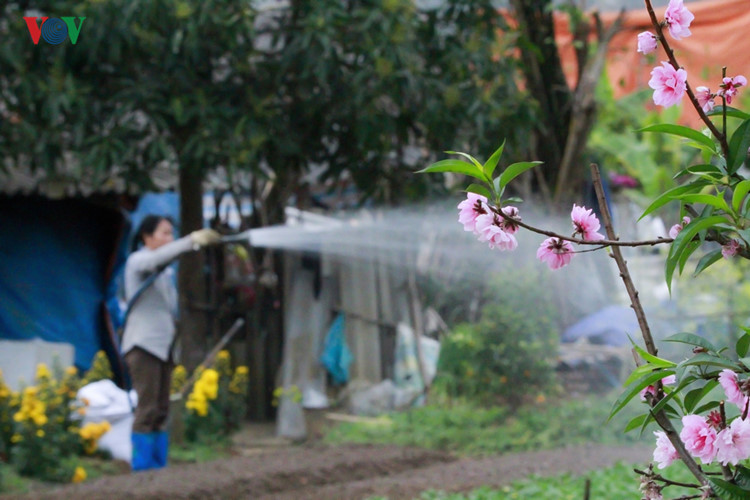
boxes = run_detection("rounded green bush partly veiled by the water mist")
[434,268,559,404]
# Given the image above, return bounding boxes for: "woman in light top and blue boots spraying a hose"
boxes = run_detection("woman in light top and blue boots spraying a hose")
[121,215,220,471]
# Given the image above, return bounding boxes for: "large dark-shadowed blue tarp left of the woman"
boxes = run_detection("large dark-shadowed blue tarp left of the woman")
[0,196,124,371]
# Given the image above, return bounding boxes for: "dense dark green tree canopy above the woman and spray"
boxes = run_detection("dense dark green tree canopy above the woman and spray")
[0,0,531,206]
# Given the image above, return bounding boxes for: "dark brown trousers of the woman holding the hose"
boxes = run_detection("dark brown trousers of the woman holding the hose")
[125,347,172,433]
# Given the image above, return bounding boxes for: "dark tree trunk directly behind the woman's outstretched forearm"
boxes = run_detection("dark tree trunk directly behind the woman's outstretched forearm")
[178,165,210,371]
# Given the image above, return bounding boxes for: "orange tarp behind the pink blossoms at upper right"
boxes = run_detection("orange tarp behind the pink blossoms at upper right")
[555,0,750,125]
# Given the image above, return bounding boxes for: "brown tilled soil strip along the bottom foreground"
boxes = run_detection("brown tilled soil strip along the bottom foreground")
[2,445,652,500]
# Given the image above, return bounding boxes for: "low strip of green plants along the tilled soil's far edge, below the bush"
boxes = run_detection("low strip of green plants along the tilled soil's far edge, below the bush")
[325,397,650,455]
